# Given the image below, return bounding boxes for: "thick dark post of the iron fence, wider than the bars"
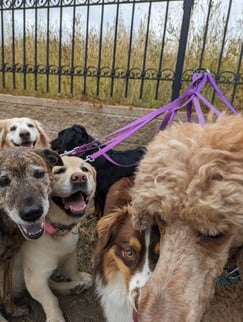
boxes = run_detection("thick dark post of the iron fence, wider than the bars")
[171,0,194,101]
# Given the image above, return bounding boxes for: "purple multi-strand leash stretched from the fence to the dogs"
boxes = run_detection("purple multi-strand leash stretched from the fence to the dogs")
[65,71,237,166]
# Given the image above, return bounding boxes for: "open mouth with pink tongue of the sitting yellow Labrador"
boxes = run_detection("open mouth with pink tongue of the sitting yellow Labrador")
[62,191,89,217]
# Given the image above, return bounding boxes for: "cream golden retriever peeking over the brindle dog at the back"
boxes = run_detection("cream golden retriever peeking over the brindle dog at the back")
[0,117,49,149]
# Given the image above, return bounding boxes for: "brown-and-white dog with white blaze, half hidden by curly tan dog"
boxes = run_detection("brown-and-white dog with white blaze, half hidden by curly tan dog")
[94,178,160,322]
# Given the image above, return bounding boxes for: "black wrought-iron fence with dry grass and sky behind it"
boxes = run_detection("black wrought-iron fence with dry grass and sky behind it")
[0,0,243,109]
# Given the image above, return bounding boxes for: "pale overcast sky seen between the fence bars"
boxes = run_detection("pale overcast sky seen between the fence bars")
[0,0,243,38]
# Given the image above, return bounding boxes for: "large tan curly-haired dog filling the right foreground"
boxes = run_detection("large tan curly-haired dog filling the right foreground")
[131,115,243,322]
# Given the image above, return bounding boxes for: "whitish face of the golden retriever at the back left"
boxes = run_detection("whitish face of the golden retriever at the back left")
[6,117,40,148]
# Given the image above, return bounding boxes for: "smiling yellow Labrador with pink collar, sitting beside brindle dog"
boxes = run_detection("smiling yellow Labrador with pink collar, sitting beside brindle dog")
[15,156,96,322]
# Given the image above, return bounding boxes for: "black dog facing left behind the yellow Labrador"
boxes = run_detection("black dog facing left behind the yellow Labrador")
[50,124,146,216]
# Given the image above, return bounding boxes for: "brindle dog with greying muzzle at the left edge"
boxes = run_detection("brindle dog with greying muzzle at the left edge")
[0,148,62,321]
